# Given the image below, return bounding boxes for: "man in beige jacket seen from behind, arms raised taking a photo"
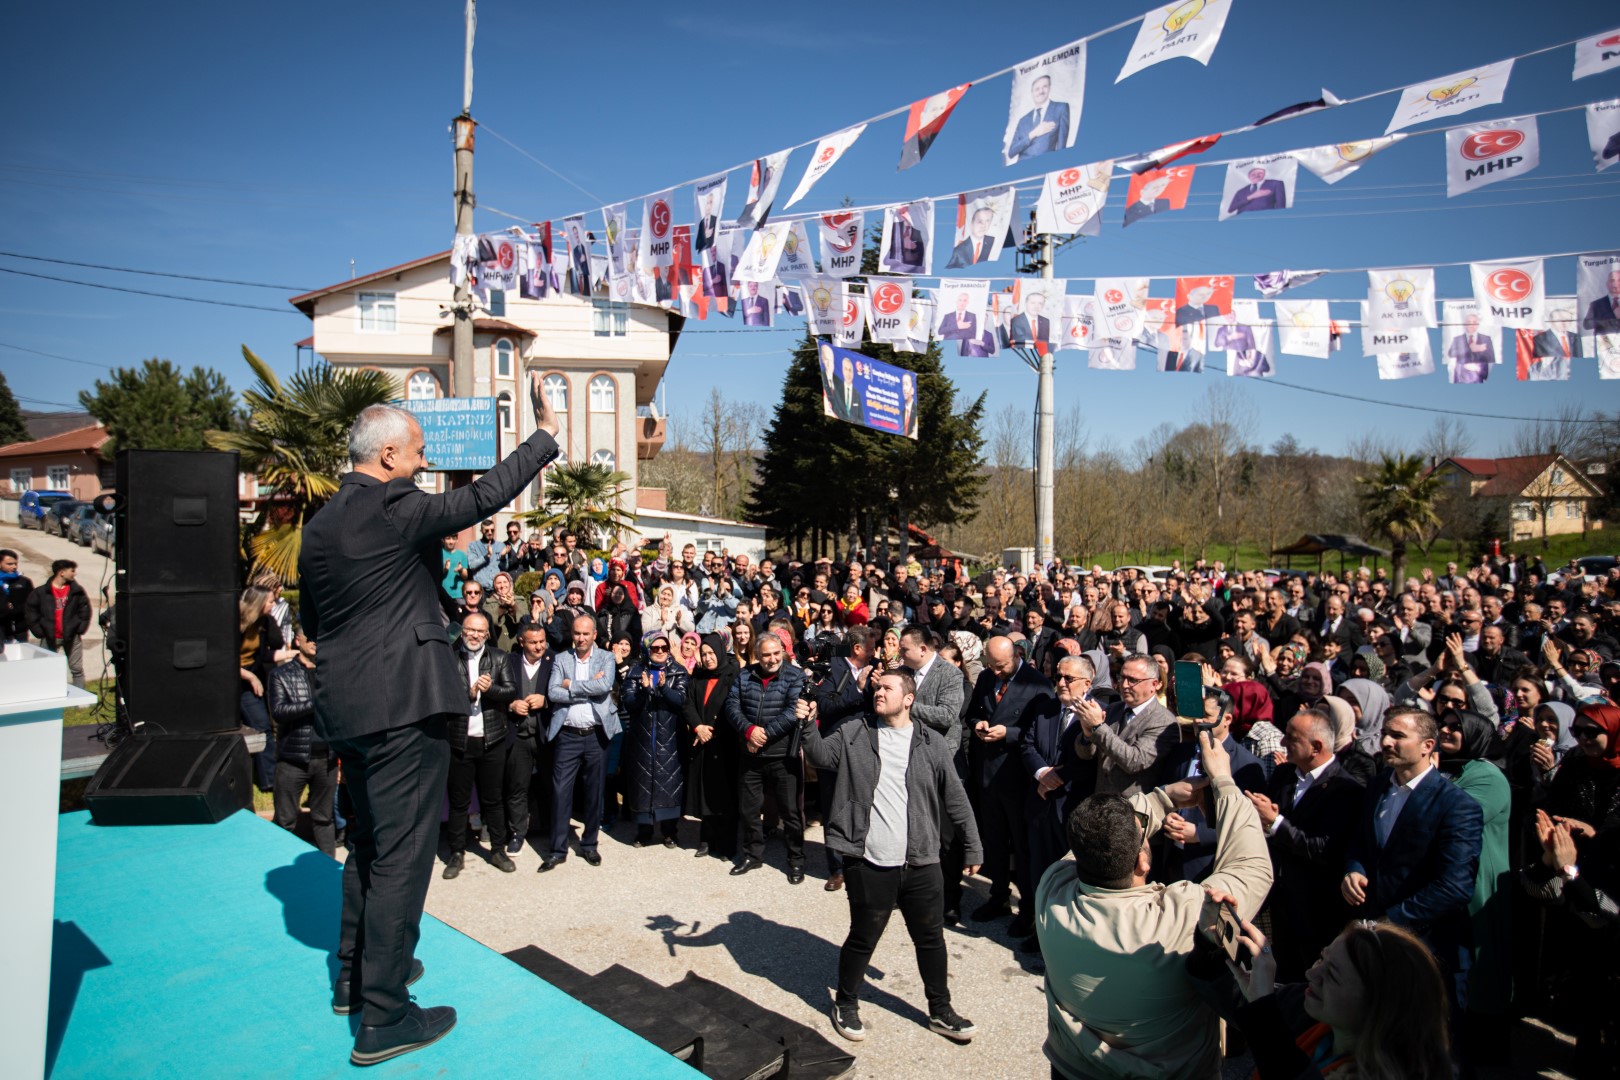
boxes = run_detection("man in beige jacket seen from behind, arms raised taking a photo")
[1035,733,1272,1080]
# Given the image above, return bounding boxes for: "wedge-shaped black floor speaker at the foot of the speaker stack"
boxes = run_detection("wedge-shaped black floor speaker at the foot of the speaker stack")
[84,732,253,826]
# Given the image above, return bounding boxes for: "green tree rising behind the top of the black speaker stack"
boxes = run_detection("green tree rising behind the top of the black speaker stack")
[79,358,241,458]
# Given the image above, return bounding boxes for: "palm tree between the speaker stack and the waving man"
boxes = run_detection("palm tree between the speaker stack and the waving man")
[207,345,399,581]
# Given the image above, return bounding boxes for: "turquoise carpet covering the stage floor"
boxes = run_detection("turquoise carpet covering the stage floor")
[49,811,698,1080]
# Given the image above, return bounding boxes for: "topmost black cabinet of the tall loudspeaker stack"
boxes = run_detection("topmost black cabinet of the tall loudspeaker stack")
[115,450,241,594]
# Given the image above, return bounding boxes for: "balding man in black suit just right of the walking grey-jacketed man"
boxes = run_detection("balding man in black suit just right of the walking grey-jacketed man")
[967,636,1058,938]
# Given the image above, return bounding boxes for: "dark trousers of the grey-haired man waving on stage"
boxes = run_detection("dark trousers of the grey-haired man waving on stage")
[332,716,450,1025]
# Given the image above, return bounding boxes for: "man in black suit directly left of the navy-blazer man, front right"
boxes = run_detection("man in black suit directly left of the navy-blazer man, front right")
[1249,709,1364,981]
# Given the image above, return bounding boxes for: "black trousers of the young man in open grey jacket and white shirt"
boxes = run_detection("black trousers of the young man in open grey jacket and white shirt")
[838,858,951,1015]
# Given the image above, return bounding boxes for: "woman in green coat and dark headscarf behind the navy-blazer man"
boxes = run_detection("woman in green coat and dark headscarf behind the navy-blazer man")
[1438,705,1513,1042]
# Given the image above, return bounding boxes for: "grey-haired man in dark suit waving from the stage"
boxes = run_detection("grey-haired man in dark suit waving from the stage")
[298,372,557,1064]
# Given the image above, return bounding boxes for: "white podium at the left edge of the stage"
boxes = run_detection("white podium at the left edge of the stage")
[0,643,96,1077]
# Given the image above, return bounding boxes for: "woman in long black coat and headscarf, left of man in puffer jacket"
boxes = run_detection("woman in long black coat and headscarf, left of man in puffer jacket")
[685,633,740,860]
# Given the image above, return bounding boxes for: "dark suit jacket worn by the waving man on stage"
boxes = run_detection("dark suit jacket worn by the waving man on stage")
[298,431,557,742]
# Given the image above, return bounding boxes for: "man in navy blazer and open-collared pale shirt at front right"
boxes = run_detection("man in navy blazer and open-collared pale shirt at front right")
[1340,708,1484,1017]
